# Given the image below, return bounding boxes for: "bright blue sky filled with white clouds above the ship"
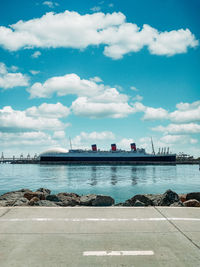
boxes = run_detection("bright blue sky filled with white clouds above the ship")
[0,0,200,157]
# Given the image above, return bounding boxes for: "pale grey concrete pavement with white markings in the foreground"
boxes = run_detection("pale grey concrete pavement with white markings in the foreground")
[0,207,200,267]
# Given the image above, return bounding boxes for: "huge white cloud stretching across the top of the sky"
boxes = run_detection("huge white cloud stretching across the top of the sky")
[0,10,198,59]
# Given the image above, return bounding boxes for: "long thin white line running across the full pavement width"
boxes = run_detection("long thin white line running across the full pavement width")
[0,217,200,222]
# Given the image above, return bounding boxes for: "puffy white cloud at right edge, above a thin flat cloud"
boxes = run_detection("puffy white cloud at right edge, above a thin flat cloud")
[170,101,200,123]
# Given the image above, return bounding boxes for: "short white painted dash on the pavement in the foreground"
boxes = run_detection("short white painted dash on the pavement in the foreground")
[83,250,154,256]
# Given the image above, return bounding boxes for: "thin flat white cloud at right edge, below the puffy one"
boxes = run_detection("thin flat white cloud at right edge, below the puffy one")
[152,123,200,134]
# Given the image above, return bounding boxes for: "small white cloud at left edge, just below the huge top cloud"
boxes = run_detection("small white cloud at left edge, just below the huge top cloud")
[0,62,29,89]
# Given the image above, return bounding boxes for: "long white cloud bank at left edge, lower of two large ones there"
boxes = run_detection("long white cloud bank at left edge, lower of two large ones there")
[0,104,68,132]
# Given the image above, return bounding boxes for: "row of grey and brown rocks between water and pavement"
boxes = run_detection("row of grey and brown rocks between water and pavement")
[0,188,200,207]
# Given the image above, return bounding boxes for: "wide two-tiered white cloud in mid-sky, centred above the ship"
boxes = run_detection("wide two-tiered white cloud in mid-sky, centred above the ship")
[28,74,134,118]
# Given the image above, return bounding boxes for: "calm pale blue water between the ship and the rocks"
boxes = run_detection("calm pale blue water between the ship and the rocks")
[0,164,200,202]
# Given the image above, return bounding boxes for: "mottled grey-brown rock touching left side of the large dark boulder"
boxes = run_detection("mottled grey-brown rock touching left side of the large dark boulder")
[56,193,80,207]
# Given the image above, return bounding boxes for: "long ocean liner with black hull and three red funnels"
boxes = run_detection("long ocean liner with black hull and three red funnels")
[39,143,176,164]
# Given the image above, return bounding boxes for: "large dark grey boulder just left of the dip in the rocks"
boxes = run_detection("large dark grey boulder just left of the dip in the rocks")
[80,194,115,206]
